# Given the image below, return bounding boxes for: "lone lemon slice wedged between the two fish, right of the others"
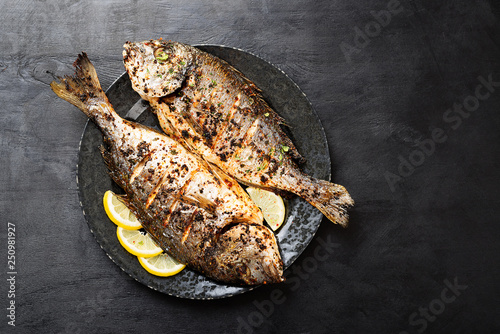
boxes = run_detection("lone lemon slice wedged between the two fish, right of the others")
[247,187,285,231]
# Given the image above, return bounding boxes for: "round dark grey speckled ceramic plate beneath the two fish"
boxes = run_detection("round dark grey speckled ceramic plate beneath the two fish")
[78,45,330,299]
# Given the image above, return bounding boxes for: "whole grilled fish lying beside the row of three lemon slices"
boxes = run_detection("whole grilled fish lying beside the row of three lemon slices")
[51,53,283,284]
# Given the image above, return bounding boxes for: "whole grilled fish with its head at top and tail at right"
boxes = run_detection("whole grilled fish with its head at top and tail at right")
[123,39,354,227]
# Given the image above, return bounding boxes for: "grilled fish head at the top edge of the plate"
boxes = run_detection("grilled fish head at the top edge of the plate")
[123,39,194,99]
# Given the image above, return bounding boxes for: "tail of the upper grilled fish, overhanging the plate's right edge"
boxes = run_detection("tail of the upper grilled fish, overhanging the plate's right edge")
[300,178,354,227]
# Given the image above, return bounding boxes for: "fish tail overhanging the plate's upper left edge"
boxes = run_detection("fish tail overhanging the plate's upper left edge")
[50,52,109,118]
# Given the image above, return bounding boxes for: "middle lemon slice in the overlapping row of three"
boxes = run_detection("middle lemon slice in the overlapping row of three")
[116,226,163,257]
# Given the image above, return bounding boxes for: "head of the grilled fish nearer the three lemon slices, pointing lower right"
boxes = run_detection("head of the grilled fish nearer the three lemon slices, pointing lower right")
[216,224,284,285]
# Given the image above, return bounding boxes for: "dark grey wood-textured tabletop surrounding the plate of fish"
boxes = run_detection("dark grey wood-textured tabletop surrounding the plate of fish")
[0,0,500,333]
